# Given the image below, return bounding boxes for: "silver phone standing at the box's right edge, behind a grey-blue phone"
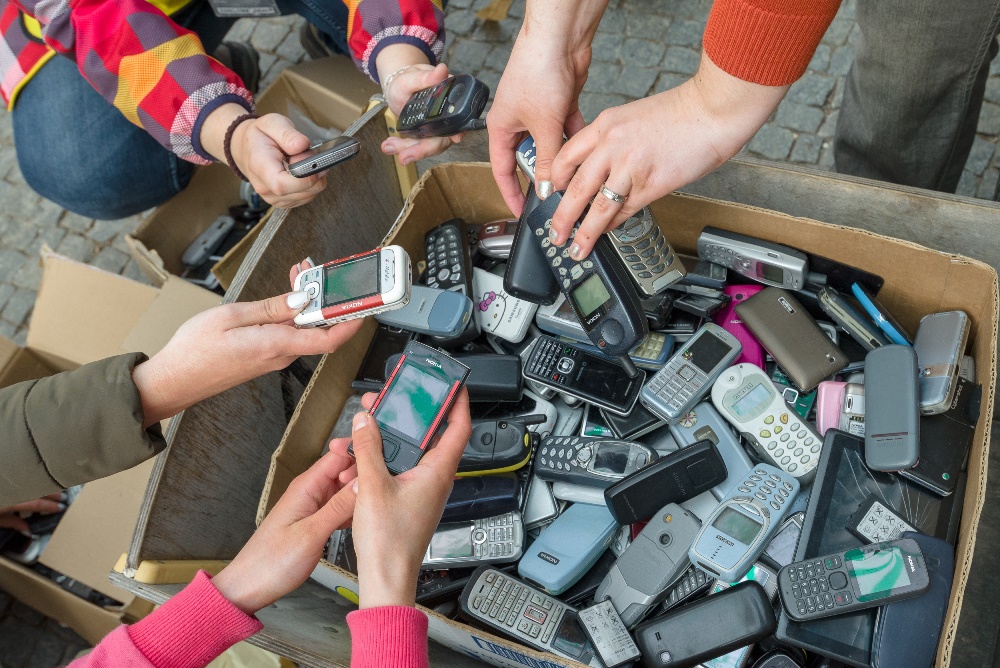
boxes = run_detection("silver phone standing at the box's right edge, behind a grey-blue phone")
[913,311,970,415]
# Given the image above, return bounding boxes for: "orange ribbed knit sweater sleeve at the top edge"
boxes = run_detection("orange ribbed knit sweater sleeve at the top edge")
[704,0,840,86]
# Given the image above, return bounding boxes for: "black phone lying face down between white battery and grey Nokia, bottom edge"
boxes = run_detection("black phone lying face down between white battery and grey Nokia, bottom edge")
[635,581,777,668]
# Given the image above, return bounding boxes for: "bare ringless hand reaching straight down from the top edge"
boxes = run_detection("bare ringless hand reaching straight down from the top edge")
[486,0,607,216]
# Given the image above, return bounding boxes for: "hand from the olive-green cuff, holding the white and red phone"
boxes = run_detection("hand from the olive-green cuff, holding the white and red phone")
[132,260,363,426]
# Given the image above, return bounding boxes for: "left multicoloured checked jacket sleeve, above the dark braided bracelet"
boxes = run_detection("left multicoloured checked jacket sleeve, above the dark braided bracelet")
[15,0,253,164]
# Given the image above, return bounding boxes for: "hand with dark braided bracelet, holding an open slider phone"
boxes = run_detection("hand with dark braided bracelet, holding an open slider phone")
[201,103,326,209]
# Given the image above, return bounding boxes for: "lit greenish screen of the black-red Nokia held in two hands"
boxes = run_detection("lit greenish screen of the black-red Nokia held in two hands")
[375,362,451,444]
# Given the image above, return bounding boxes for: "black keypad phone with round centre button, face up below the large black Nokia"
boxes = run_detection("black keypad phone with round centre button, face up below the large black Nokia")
[522,336,646,415]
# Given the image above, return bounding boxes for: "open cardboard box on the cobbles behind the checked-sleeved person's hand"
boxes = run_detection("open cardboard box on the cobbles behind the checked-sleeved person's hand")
[125,57,380,288]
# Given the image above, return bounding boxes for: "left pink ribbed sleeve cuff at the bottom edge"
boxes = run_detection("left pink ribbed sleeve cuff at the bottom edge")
[128,571,264,668]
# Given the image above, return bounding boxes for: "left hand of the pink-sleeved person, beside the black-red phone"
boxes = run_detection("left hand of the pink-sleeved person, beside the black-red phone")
[212,452,357,615]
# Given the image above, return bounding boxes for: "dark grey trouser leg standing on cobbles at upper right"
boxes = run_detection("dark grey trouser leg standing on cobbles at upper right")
[834,0,1000,199]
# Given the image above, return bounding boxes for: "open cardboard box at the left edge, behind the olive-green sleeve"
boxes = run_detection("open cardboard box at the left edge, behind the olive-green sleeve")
[0,252,219,643]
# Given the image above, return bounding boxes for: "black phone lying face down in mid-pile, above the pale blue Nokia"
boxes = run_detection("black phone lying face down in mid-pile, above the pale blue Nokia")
[604,441,726,528]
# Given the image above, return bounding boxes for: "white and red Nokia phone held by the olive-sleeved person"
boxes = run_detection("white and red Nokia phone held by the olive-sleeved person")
[294,246,412,327]
